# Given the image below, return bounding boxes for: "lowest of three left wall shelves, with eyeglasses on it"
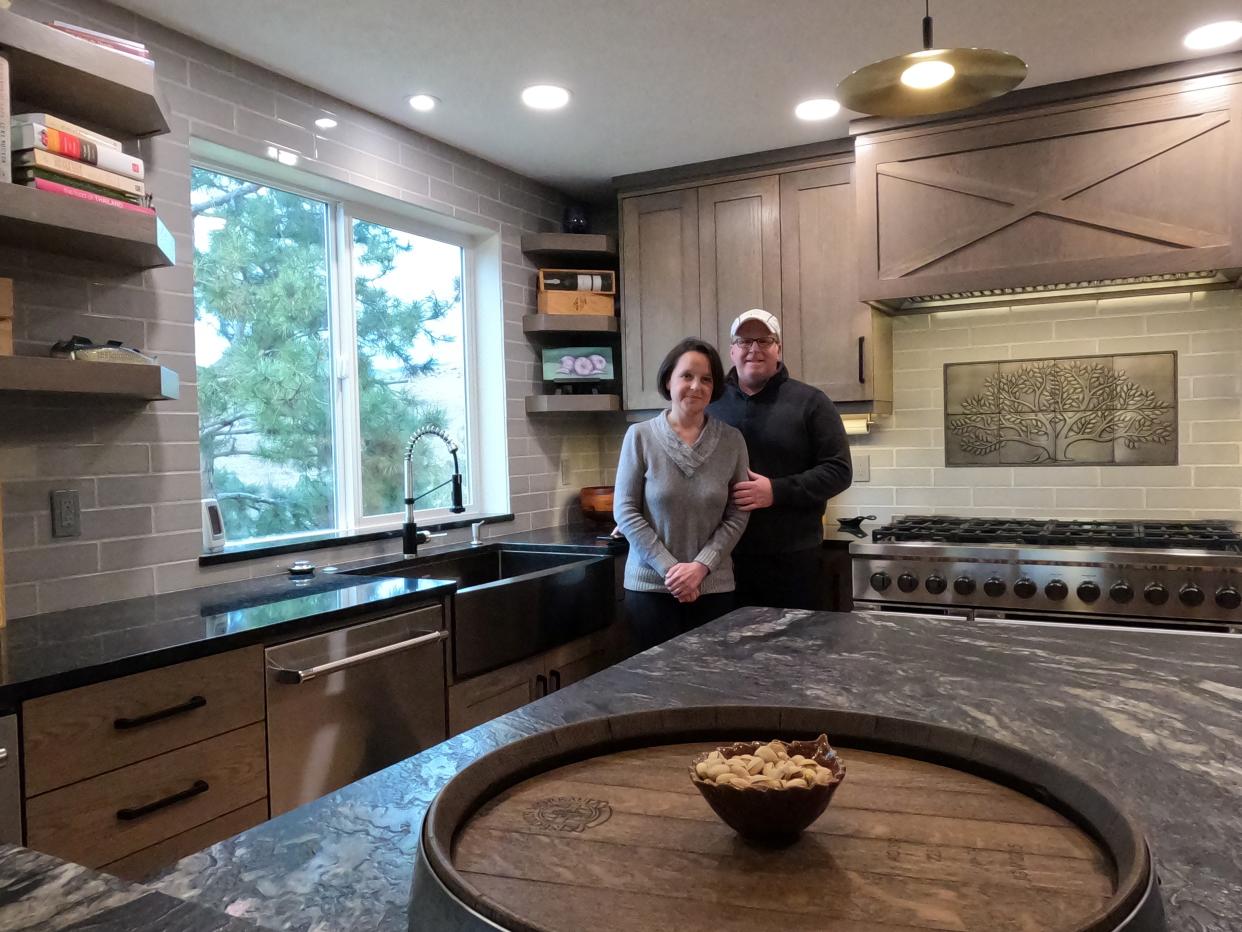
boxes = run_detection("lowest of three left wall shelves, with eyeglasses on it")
[0,355,181,401]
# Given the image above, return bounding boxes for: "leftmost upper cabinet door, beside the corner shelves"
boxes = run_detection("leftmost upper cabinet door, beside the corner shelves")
[621,189,699,409]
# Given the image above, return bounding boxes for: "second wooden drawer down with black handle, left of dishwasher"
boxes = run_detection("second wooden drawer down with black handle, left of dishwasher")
[26,723,267,867]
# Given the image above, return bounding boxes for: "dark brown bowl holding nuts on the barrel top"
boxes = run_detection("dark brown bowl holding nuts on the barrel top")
[689,734,846,847]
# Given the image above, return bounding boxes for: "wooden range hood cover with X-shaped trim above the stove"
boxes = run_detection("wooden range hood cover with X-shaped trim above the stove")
[856,72,1242,307]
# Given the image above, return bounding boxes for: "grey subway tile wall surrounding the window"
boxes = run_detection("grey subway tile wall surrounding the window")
[0,0,625,618]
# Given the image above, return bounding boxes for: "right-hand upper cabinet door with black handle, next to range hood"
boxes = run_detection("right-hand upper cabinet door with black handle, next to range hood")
[780,164,892,401]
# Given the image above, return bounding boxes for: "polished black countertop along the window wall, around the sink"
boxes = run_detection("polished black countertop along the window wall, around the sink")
[0,528,625,707]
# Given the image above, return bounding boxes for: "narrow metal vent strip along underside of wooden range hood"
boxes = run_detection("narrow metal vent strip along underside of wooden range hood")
[869,268,1242,314]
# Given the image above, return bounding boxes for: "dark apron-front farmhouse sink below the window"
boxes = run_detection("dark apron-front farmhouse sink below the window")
[348,544,616,678]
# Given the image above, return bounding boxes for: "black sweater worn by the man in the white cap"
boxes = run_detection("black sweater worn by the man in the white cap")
[708,363,853,554]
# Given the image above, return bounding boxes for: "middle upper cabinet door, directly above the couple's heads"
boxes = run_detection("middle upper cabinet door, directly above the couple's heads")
[698,175,781,352]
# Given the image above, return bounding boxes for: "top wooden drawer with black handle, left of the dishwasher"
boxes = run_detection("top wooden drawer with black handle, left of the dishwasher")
[22,646,263,797]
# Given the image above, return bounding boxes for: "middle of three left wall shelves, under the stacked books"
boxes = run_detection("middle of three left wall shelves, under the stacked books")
[0,183,176,268]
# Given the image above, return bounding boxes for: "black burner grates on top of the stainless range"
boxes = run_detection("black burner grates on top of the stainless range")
[872,514,1242,553]
